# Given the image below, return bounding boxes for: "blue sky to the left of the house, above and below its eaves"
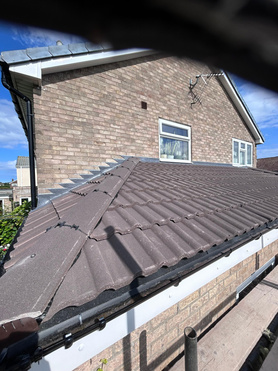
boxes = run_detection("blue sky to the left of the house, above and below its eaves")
[0,21,82,182]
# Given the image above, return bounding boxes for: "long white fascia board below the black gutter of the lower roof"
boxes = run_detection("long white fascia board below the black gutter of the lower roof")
[31,229,278,371]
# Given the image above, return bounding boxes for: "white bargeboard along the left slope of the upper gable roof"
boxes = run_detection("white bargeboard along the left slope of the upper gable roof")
[9,49,154,85]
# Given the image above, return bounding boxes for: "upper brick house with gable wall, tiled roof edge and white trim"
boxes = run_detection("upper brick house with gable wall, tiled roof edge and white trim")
[2,44,263,198]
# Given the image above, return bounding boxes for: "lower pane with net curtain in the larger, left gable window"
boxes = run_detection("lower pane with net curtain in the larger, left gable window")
[160,137,189,160]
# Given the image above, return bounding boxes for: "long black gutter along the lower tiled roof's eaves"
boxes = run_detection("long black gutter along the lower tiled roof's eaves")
[33,219,278,362]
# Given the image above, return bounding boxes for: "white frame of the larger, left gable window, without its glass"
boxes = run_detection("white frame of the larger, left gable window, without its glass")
[158,118,191,163]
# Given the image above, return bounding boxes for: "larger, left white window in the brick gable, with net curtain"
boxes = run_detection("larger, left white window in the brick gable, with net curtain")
[159,119,191,162]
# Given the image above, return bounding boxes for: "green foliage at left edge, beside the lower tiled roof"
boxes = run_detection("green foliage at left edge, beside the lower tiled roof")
[0,202,31,260]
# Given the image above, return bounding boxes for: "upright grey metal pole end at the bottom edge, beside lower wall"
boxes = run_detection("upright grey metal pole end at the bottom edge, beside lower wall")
[184,327,198,371]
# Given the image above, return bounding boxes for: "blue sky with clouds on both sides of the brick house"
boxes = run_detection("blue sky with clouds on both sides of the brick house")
[0,21,278,182]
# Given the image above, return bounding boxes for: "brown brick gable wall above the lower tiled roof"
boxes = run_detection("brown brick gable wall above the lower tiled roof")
[31,55,255,193]
